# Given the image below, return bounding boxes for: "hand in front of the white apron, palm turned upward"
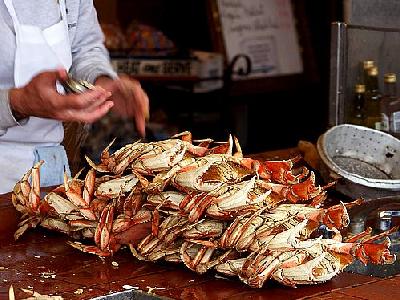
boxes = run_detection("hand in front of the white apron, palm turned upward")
[9,69,113,123]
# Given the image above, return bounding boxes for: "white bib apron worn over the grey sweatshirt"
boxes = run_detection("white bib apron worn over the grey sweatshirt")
[0,0,72,194]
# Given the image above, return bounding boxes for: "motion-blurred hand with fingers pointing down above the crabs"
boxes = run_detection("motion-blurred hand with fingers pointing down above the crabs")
[95,75,149,137]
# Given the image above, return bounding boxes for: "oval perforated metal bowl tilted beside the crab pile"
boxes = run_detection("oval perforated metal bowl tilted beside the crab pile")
[317,124,400,198]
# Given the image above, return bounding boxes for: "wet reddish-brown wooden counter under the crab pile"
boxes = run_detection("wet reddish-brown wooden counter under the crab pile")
[0,151,400,300]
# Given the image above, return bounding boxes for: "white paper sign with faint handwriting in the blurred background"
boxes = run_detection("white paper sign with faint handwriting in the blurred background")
[217,0,303,79]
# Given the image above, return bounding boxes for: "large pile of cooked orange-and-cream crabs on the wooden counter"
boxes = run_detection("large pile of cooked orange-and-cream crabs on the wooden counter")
[12,132,397,288]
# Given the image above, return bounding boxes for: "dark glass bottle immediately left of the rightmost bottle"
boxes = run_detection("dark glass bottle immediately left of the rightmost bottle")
[365,66,381,130]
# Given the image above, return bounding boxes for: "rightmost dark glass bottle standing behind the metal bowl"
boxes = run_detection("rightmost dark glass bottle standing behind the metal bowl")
[380,73,397,132]
